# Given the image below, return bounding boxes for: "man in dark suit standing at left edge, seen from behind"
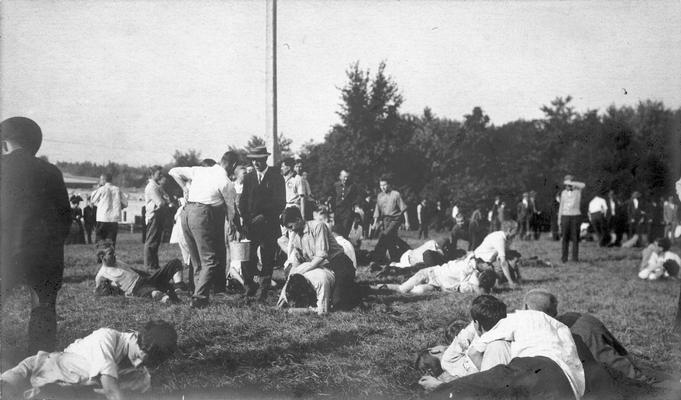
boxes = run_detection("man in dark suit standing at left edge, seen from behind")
[0,117,71,354]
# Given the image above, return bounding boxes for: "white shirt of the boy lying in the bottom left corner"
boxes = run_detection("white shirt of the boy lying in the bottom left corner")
[64,328,142,378]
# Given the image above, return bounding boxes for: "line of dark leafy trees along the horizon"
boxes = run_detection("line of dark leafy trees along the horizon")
[56,62,681,217]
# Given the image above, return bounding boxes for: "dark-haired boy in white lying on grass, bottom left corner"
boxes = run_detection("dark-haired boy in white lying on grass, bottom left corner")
[0,320,177,400]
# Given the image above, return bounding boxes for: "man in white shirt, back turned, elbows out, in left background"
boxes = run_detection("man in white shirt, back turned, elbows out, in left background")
[90,173,128,246]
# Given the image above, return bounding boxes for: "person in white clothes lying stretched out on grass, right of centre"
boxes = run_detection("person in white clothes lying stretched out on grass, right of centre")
[375,253,497,294]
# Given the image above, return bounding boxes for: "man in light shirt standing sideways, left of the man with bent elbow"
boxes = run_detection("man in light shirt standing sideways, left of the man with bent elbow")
[144,165,168,269]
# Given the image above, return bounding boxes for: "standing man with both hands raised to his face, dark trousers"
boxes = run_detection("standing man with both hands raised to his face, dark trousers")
[558,175,586,262]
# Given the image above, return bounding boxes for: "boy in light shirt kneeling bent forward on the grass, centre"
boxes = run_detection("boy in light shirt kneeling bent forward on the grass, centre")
[277,207,357,314]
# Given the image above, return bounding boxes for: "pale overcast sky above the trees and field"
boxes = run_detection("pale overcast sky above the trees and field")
[0,0,681,165]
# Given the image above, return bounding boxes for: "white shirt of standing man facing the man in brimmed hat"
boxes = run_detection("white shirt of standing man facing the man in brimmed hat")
[168,164,236,206]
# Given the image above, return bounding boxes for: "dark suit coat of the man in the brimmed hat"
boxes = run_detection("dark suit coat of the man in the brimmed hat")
[239,167,286,240]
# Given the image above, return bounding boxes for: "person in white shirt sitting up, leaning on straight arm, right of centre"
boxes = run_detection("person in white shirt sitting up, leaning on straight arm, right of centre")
[473,221,521,288]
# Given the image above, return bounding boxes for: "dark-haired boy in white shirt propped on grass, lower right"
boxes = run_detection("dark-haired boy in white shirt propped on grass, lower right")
[417,295,511,390]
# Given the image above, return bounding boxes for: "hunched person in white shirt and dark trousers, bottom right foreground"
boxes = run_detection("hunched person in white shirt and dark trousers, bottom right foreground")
[430,295,585,399]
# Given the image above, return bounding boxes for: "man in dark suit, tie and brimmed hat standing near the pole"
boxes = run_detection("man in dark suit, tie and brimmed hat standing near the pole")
[239,146,286,300]
